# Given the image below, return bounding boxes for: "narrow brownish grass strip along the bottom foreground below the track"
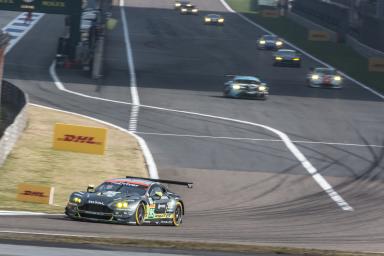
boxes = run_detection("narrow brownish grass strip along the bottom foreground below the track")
[0,232,380,256]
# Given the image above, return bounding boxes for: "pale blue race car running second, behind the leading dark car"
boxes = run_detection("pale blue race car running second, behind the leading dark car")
[223,76,268,99]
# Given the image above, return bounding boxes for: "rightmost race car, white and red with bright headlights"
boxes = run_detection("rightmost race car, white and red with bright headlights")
[307,68,343,89]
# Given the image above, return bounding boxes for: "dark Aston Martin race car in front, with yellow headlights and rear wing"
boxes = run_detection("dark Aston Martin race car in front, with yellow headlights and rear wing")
[65,176,193,226]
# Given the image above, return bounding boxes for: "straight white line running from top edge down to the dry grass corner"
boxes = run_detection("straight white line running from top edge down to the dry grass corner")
[120,0,140,132]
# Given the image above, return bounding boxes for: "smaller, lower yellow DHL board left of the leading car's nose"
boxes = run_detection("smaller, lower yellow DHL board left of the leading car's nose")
[16,183,55,204]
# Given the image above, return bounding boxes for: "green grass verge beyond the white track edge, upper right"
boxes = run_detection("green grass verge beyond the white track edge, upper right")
[226,0,384,92]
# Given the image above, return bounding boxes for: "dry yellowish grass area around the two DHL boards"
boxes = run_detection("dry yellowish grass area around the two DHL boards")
[0,106,148,213]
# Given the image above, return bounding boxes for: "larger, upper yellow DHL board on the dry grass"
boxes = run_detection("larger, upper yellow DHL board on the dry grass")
[53,123,107,155]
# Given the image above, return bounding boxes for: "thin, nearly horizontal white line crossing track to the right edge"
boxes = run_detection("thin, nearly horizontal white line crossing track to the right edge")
[136,132,384,148]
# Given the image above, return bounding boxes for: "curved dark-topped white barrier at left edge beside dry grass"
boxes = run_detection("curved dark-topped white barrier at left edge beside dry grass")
[0,81,28,166]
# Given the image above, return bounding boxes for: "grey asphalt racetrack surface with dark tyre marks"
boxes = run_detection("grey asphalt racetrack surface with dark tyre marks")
[0,0,384,252]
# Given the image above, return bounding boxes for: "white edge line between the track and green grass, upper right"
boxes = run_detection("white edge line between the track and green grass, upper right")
[220,0,384,100]
